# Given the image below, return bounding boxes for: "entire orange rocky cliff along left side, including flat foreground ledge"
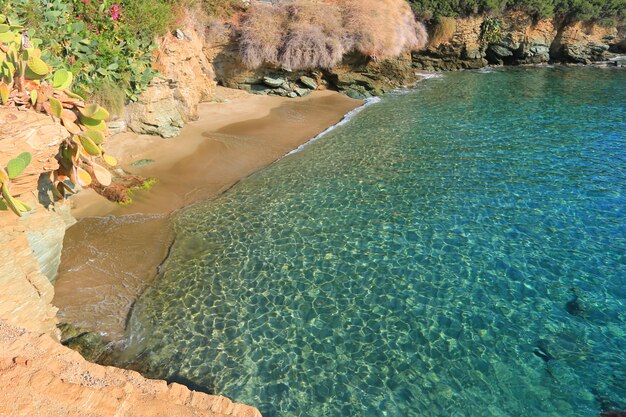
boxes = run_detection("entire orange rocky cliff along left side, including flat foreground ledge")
[0,108,261,417]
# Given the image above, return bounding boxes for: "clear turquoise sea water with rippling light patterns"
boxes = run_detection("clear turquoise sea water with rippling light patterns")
[123,68,626,417]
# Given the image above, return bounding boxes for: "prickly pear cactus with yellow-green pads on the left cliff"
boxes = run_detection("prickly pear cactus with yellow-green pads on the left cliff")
[0,15,117,212]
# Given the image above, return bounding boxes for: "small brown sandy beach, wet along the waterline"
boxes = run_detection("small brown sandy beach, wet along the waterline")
[53,89,362,340]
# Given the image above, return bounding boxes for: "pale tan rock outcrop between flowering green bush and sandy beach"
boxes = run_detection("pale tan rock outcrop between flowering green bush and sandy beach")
[126,28,215,138]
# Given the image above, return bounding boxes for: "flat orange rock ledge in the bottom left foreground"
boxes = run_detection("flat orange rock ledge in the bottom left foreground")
[0,321,261,417]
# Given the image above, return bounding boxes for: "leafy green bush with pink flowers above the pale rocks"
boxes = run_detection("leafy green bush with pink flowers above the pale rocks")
[7,0,155,100]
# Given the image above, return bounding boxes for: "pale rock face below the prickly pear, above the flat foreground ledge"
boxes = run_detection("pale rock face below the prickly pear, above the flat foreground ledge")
[0,108,73,338]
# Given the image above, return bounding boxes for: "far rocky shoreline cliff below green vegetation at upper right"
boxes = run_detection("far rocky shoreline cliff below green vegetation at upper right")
[413,12,625,71]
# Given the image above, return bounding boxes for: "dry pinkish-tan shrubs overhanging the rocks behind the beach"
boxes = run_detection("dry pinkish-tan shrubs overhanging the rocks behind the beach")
[239,0,428,69]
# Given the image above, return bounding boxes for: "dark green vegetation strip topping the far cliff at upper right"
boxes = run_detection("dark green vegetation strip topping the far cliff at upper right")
[410,0,626,24]
